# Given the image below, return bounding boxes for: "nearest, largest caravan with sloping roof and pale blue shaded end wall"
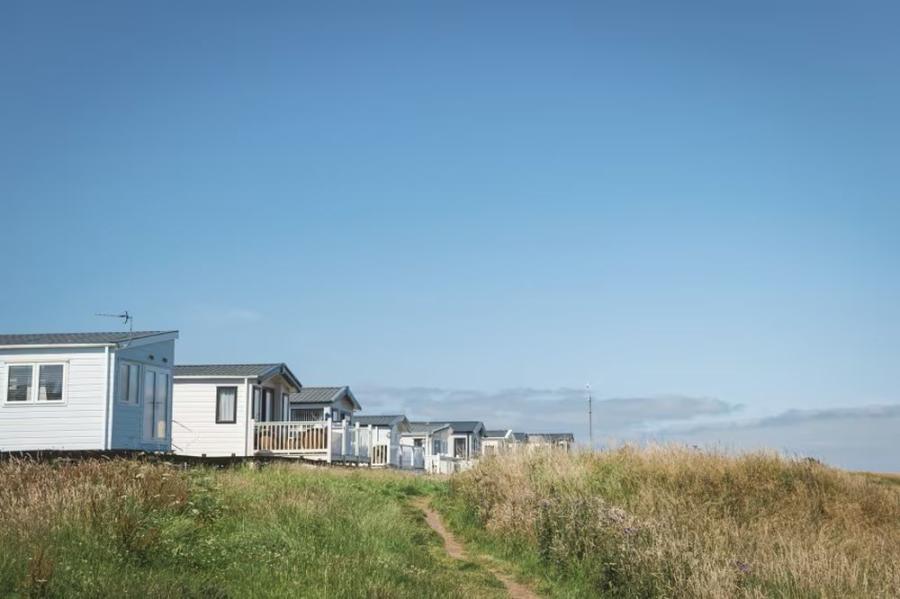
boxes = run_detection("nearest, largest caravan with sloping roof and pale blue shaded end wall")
[0,331,178,451]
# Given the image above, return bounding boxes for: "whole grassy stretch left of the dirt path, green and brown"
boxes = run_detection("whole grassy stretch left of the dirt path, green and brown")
[0,460,504,598]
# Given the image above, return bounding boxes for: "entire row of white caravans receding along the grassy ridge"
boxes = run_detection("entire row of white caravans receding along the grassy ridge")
[0,331,571,472]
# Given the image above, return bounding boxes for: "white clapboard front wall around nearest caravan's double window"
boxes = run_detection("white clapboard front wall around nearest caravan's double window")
[0,348,107,451]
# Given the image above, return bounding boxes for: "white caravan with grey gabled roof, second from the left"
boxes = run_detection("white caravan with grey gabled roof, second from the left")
[172,362,301,457]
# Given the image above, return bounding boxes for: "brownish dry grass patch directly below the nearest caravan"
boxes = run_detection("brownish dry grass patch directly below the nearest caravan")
[0,460,196,596]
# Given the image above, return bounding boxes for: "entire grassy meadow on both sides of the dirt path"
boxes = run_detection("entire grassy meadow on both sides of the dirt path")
[0,448,900,598]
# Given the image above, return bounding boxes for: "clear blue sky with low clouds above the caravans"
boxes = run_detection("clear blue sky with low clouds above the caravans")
[0,2,900,470]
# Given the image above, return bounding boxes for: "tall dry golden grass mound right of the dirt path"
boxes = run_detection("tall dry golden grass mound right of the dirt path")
[446,447,900,597]
